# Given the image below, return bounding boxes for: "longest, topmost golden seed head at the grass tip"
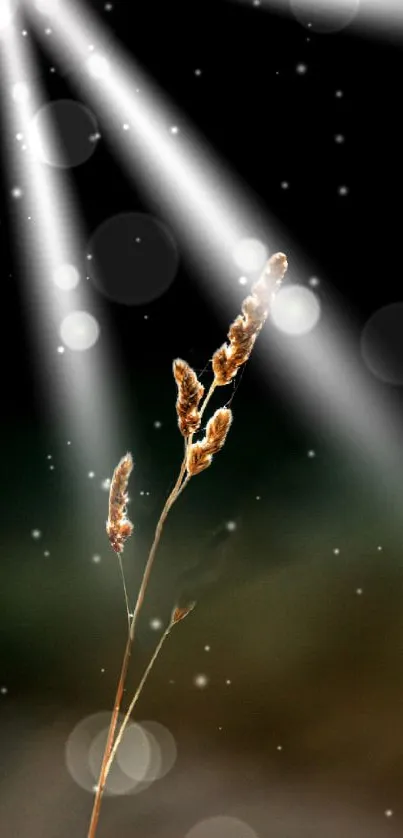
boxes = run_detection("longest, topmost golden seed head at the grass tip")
[212,253,288,387]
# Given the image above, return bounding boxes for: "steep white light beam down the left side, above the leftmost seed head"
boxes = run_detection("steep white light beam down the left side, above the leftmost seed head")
[0,9,134,516]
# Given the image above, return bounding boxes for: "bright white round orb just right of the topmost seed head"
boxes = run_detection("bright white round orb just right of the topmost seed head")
[270,285,320,335]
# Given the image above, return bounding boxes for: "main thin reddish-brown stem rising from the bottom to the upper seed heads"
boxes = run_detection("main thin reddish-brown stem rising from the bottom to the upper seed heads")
[87,440,187,838]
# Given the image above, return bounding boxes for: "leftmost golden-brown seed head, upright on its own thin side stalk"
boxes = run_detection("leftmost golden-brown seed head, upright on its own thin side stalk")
[106,452,133,553]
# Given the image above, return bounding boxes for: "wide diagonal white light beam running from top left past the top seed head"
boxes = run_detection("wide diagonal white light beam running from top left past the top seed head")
[22,0,403,532]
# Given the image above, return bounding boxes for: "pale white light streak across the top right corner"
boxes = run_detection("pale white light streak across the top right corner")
[229,0,403,35]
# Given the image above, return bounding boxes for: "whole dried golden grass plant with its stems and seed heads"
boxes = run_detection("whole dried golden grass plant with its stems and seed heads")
[87,253,288,838]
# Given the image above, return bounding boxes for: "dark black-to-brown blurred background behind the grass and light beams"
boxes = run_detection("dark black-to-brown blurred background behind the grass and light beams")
[0,0,403,838]
